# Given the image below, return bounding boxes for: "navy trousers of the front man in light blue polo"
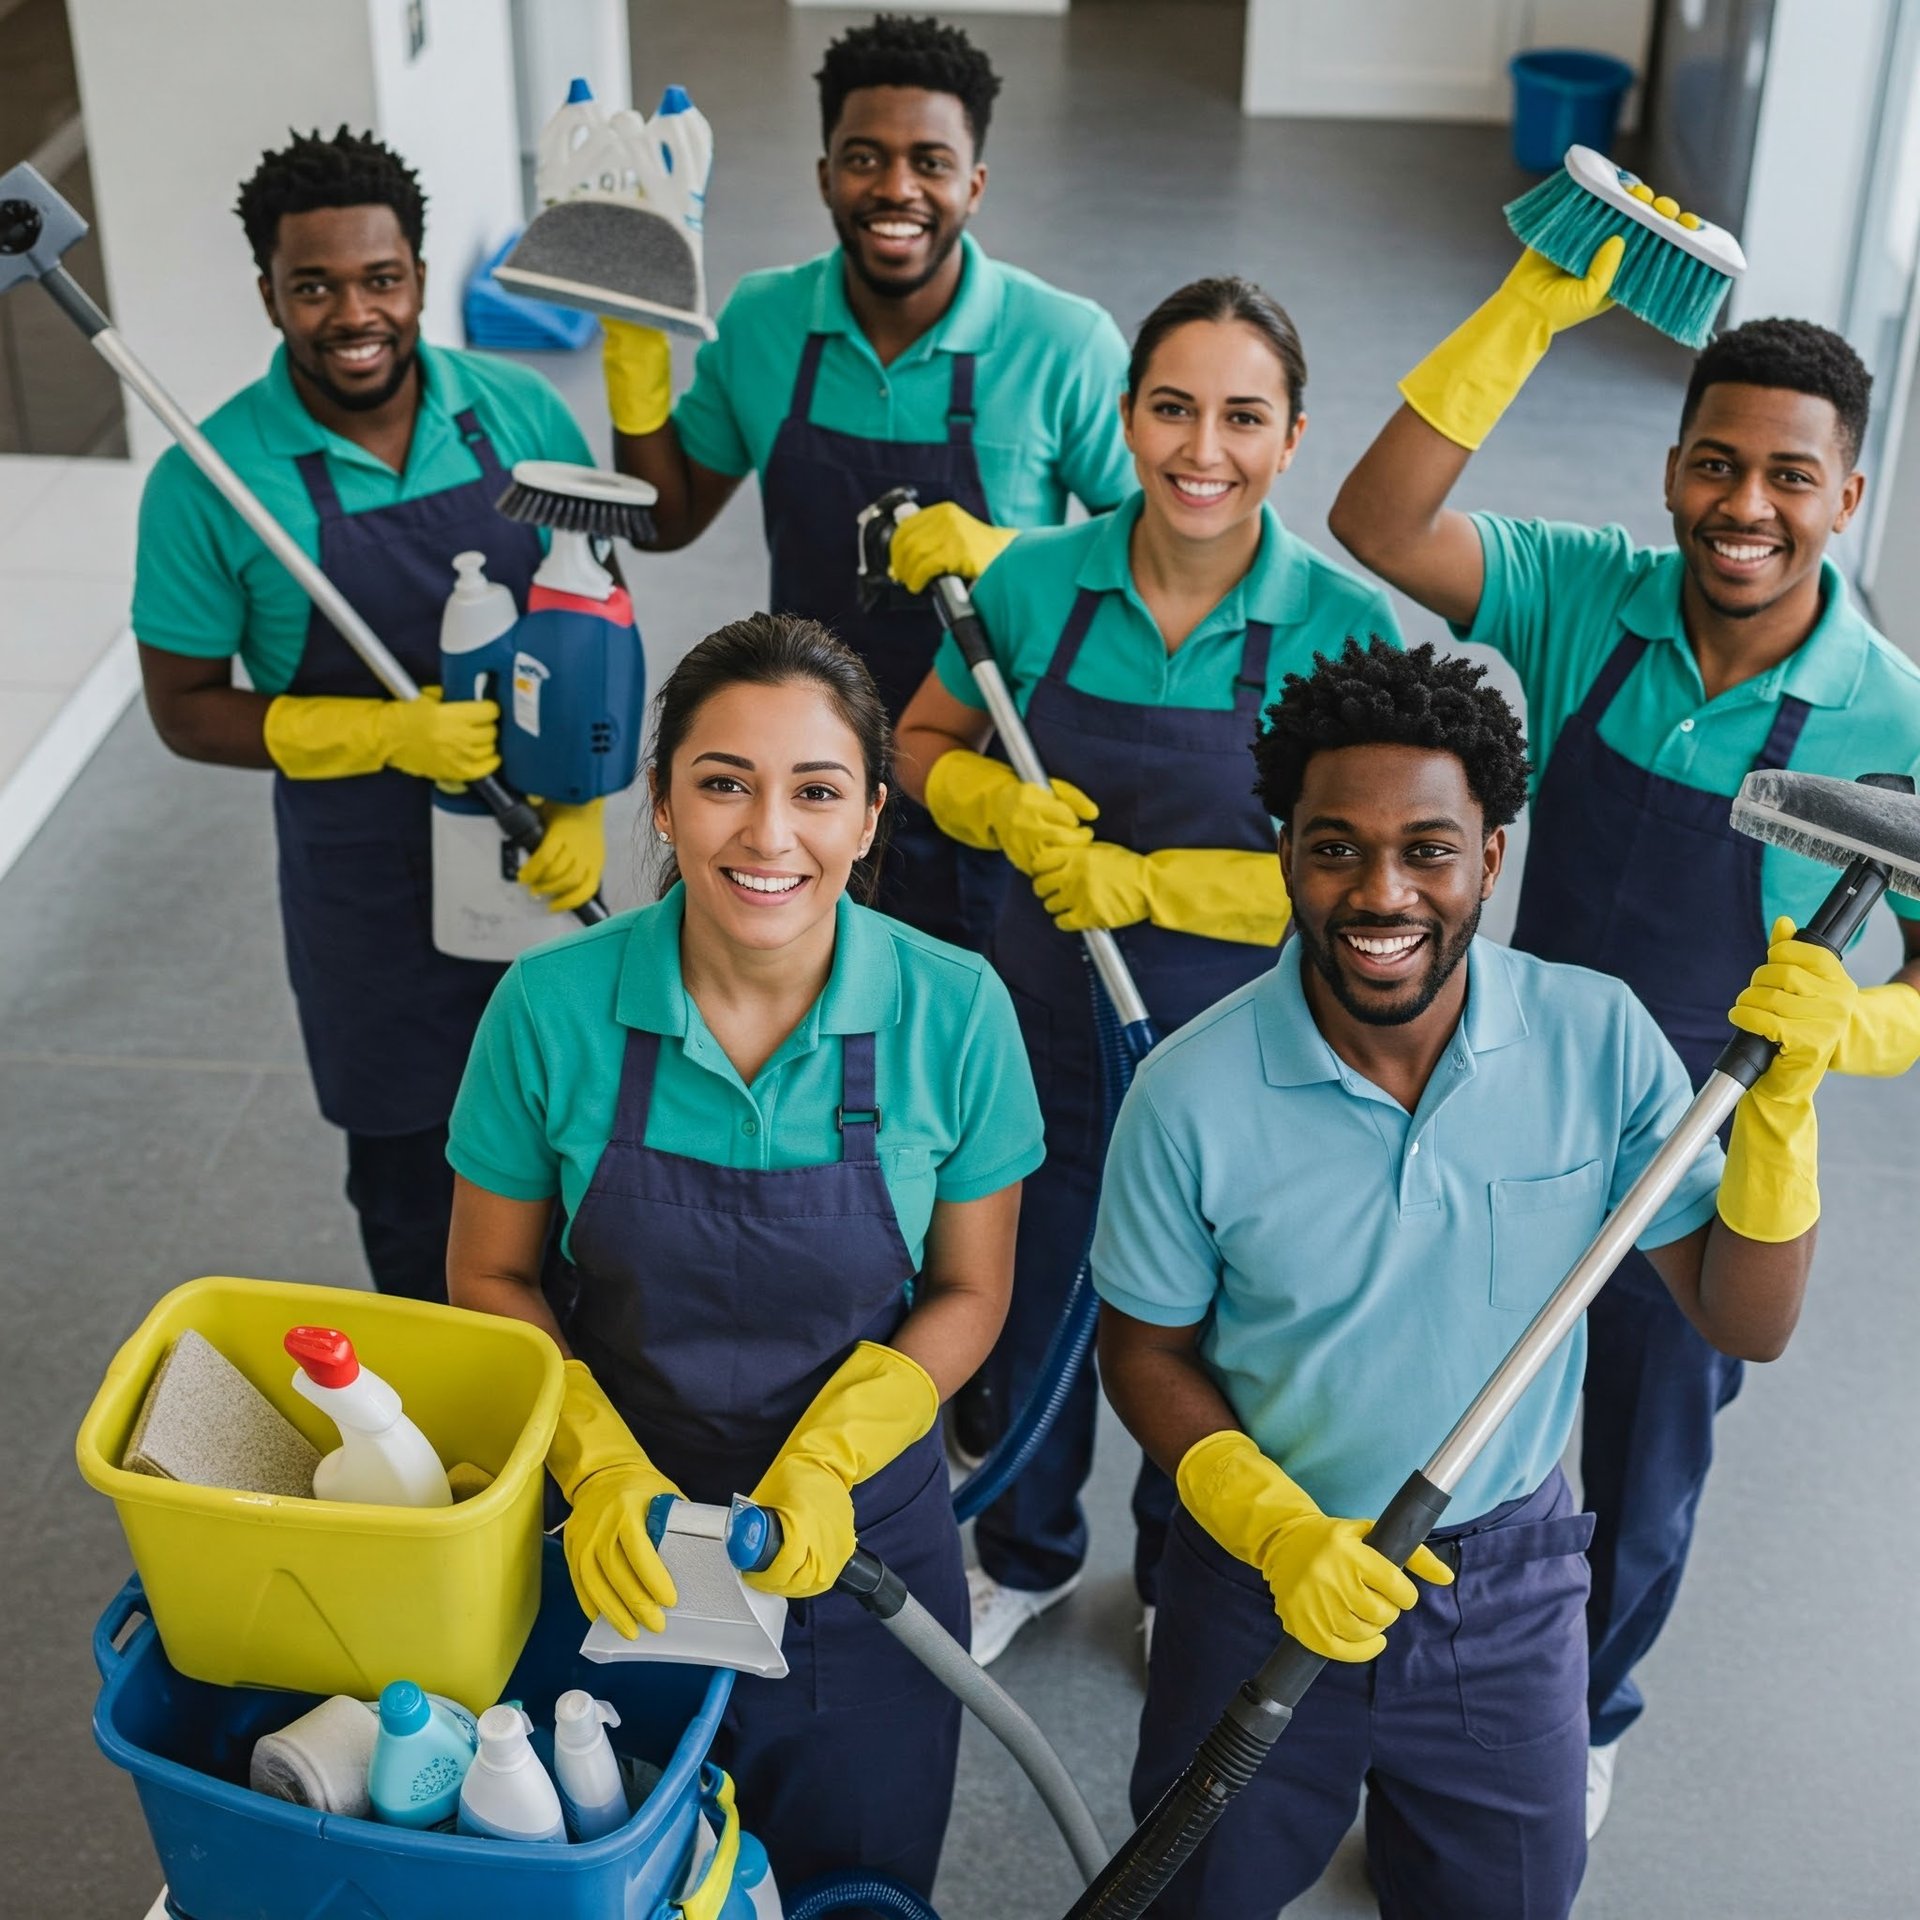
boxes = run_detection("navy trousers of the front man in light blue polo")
[1131,1467,1594,1920]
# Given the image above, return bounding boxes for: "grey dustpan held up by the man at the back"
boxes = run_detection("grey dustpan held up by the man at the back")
[493,194,714,340]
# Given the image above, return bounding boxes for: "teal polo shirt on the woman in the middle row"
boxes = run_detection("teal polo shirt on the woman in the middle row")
[933,495,1400,721]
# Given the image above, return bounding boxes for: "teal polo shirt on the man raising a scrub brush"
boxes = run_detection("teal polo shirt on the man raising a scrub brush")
[1453,513,1920,939]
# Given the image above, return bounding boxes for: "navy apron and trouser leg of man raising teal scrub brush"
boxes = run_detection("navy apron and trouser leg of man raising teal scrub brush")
[1513,634,1809,1745]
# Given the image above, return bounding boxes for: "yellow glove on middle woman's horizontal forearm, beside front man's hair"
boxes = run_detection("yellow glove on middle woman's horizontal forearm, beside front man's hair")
[1033,841,1292,947]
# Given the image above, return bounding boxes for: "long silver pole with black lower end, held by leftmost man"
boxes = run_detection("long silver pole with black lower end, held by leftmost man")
[40,267,607,925]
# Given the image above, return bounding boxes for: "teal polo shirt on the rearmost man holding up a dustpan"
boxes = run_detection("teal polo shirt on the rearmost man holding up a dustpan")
[674,234,1133,529]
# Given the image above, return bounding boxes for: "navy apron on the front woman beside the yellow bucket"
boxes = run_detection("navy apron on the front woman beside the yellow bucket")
[563,1029,968,1893]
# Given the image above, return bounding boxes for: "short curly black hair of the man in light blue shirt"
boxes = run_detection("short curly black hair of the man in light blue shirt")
[1254,636,1528,833]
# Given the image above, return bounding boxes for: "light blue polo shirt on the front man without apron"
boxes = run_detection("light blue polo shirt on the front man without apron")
[1092,939,1722,1524]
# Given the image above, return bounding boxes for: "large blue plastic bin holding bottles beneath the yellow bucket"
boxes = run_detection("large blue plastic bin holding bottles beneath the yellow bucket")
[94,1540,749,1920]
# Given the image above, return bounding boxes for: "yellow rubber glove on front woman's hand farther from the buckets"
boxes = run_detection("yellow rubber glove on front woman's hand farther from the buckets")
[747,1340,941,1599]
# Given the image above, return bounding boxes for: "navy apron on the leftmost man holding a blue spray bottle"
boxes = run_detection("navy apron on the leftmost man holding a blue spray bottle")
[273,407,541,1135]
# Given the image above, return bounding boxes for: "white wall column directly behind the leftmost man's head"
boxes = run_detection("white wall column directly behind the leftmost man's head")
[67,0,520,457]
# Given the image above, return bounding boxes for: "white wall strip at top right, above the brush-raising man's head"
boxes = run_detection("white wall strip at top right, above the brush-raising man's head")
[1726,0,1889,328]
